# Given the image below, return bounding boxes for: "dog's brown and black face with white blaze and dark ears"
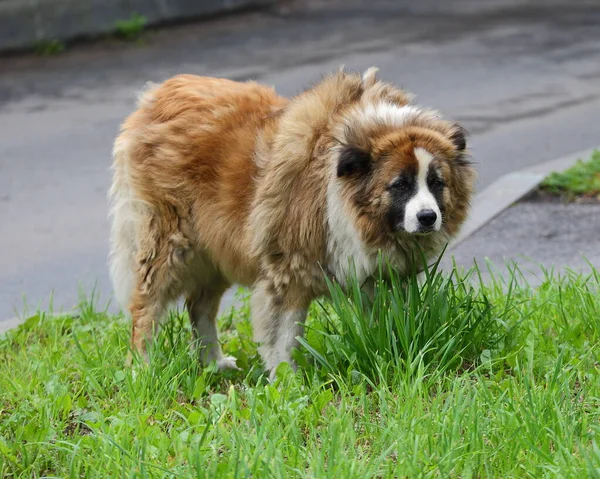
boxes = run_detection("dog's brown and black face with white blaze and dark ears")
[337,126,474,244]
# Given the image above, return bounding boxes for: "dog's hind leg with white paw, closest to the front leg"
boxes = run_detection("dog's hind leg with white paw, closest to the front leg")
[185,283,238,369]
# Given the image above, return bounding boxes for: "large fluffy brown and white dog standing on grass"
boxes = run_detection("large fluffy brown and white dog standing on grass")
[109,68,475,376]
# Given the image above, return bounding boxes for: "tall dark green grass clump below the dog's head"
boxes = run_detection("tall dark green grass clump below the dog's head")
[301,256,518,382]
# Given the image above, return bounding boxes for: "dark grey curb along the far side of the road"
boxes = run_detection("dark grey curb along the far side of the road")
[0,0,278,51]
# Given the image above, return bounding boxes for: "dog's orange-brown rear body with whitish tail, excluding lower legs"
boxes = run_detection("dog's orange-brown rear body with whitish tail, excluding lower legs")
[109,75,286,316]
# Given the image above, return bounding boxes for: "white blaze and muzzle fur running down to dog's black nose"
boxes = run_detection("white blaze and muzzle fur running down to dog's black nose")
[404,148,442,233]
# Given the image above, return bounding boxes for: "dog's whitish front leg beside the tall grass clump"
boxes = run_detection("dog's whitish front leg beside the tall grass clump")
[251,280,310,380]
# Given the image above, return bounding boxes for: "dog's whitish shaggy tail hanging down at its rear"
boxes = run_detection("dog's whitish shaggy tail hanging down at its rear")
[108,134,145,312]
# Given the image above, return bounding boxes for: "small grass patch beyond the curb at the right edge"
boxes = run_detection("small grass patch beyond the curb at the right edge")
[540,151,600,199]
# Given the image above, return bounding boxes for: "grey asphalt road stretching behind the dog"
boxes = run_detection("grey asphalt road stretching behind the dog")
[0,0,600,329]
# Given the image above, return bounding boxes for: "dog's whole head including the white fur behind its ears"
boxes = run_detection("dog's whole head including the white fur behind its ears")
[335,76,475,245]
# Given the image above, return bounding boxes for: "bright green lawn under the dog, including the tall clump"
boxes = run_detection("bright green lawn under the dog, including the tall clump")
[0,268,600,479]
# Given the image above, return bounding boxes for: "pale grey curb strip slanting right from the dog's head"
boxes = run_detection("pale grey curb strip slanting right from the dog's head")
[449,147,600,249]
